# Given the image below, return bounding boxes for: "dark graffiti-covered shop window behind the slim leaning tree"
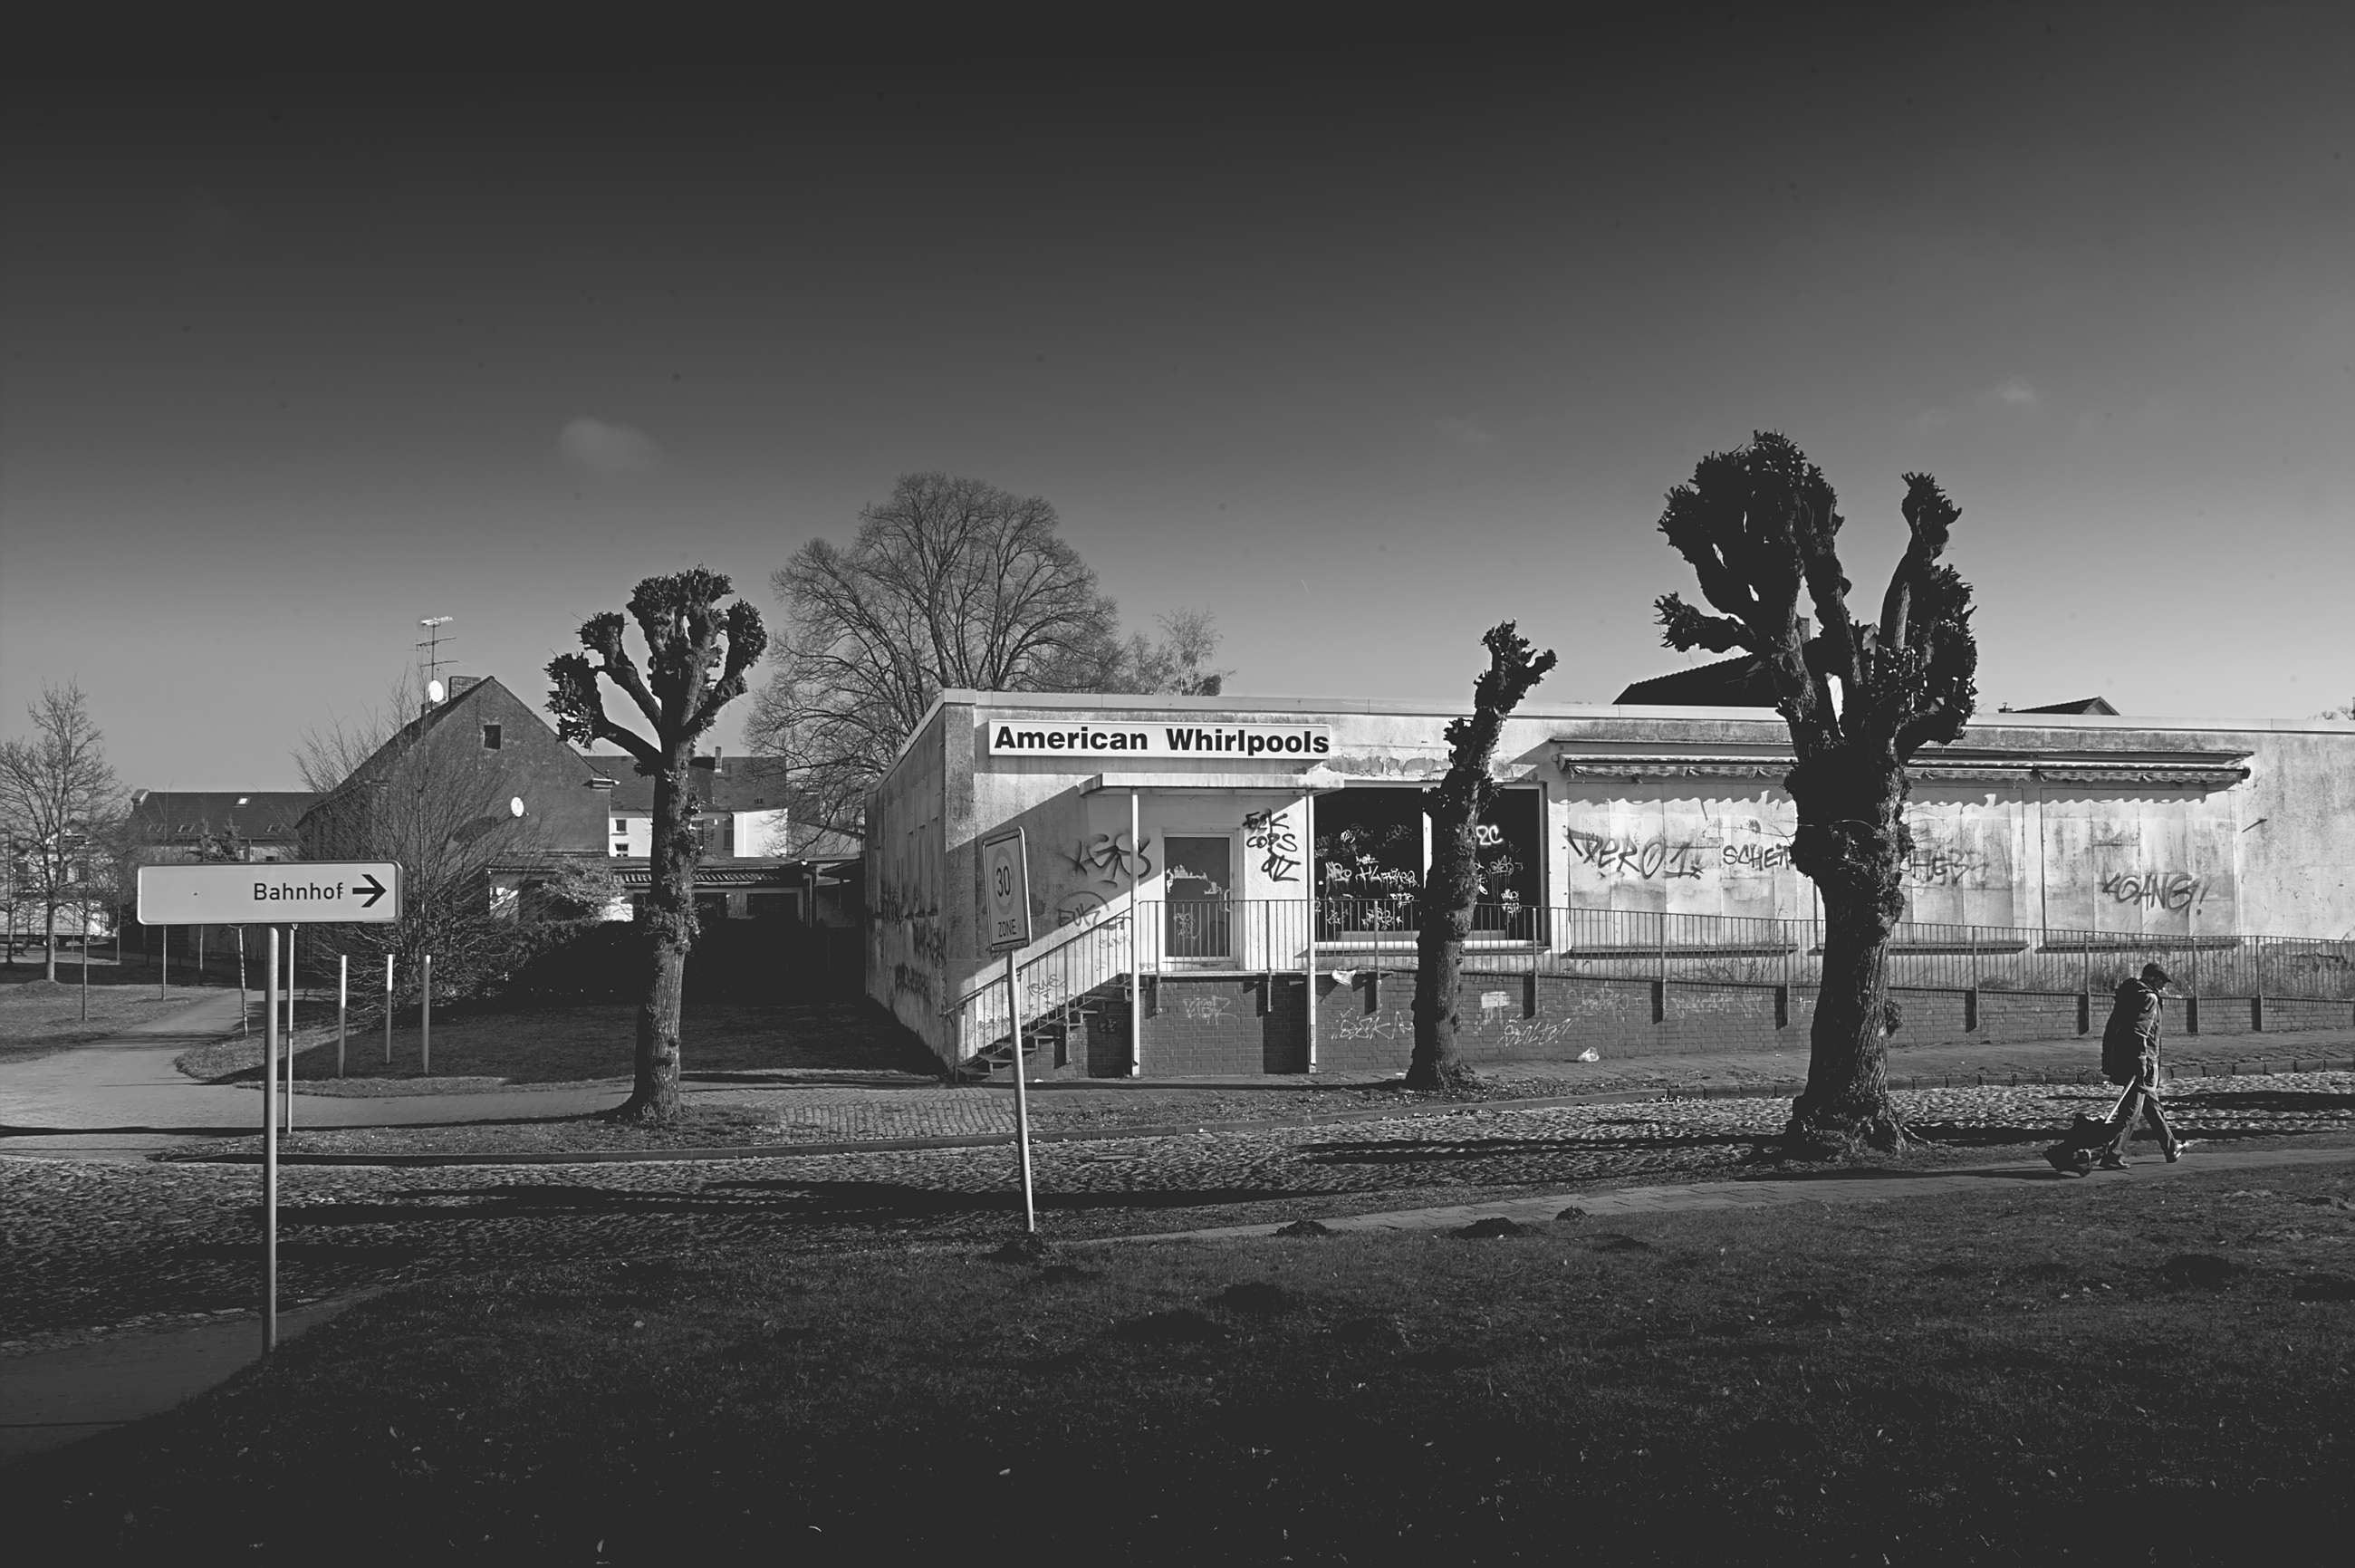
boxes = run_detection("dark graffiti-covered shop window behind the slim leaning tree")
[1316,789,1545,942]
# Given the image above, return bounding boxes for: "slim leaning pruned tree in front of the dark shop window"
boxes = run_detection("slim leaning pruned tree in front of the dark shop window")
[1406,621,1554,1090]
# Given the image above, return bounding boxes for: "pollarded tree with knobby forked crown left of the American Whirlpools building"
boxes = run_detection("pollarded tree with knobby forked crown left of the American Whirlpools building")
[549,567,768,1121]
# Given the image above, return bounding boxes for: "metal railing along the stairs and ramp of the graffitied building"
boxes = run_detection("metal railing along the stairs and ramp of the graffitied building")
[945,895,2355,1060]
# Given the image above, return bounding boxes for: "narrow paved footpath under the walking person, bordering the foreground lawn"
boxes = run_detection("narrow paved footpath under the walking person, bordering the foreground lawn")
[1111,1130,2355,1246]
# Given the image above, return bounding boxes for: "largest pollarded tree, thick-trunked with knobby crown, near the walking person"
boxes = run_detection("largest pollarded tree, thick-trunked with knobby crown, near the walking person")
[1658,431,1978,1151]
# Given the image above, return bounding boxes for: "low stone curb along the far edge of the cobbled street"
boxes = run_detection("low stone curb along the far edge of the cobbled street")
[172,1057,2355,1168]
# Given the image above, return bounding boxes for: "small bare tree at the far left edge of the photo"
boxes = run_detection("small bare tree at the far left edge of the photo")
[0,680,122,979]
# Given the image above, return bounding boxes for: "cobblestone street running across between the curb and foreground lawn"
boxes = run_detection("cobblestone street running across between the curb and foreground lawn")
[0,1073,2355,1353]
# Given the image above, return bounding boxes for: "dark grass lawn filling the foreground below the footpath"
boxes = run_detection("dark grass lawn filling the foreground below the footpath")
[0,1149,2355,1563]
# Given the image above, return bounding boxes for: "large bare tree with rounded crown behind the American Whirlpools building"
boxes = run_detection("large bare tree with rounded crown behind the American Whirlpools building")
[746,473,1225,833]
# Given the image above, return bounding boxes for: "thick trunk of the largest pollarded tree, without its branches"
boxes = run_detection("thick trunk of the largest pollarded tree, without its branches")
[1783,751,1912,1156]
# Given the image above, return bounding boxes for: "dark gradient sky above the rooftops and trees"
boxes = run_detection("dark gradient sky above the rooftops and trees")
[0,5,2355,789]
